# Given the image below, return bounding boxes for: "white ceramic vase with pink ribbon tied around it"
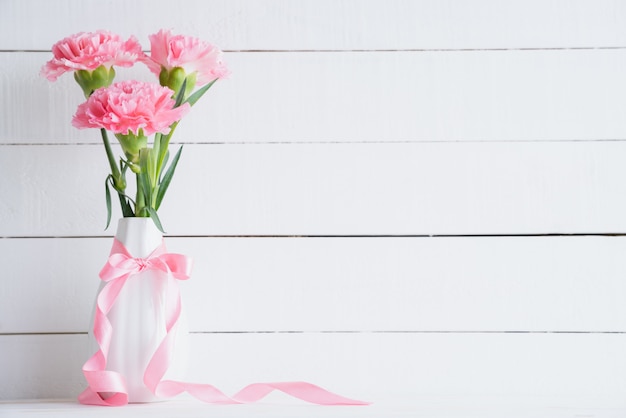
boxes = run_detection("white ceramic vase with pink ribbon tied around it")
[91,218,189,403]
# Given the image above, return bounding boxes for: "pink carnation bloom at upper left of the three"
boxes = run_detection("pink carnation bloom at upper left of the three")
[41,30,144,81]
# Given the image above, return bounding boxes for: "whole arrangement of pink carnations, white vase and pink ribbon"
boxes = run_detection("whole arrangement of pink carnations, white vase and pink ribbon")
[41,30,367,406]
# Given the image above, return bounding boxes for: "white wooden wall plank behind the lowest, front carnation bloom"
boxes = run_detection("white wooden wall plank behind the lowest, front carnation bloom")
[0,49,626,143]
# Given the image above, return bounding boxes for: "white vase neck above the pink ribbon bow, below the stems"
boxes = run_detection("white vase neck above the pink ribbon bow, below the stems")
[115,218,163,258]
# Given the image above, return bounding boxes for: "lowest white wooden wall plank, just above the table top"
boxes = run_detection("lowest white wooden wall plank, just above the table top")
[0,333,626,408]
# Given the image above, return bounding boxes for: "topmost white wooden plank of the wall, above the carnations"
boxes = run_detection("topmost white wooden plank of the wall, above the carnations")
[0,0,626,50]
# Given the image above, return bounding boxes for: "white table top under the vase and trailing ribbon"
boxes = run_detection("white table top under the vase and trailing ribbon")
[0,395,626,418]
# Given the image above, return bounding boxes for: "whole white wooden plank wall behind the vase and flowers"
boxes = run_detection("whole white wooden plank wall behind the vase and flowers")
[0,0,626,405]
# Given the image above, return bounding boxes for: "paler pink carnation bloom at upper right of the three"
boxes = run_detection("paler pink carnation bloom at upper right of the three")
[144,29,228,87]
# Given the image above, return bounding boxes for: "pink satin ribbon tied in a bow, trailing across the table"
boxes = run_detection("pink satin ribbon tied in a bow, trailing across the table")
[78,239,369,406]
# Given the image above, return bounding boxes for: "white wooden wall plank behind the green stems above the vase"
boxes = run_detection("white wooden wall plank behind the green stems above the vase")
[0,141,626,237]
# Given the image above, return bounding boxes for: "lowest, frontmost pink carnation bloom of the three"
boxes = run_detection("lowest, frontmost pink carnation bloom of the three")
[72,80,189,136]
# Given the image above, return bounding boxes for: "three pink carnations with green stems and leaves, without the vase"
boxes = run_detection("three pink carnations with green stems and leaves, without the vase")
[41,30,228,232]
